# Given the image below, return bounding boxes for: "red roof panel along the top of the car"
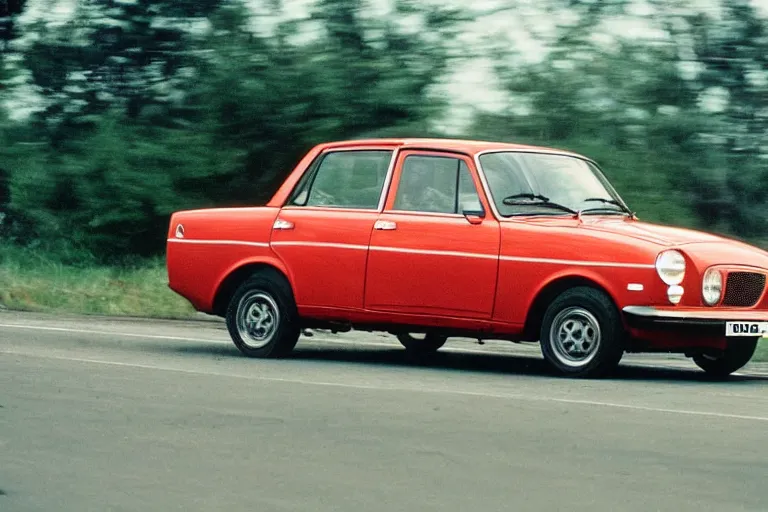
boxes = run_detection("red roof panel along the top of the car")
[320,138,585,158]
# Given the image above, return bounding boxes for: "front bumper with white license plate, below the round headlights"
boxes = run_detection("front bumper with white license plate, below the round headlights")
[622,306,768,337]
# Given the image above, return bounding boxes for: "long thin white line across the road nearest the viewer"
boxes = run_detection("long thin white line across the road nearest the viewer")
[0,350,768,422]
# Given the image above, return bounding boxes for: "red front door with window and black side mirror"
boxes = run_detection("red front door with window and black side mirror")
[365,151,500,319]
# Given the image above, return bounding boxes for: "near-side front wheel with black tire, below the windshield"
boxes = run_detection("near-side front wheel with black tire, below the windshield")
[540,287,627,378]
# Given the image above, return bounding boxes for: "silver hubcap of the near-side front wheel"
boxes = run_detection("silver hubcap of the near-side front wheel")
[549,307,602,367]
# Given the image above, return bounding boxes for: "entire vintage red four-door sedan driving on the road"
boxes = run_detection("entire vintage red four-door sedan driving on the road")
[167,139,768,377]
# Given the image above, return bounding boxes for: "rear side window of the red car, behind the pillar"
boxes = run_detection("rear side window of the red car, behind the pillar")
[288,150,392,209]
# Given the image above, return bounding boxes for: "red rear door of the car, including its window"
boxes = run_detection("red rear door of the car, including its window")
[271,147,393,312]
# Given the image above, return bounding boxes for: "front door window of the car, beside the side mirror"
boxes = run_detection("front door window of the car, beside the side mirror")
[393,155,482,213]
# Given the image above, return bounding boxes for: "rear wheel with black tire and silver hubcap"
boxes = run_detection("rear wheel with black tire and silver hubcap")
[226,270,301,358]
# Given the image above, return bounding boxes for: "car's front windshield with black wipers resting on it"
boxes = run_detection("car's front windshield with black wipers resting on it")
[479,151,629,217]
